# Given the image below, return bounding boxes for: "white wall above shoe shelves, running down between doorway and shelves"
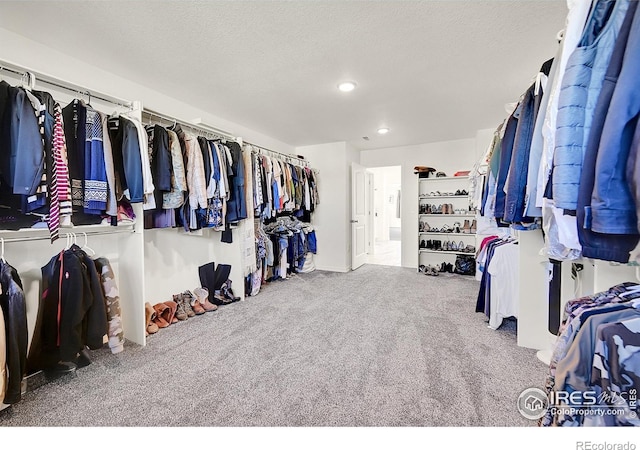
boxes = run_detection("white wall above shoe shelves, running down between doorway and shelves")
[360,139,476,268]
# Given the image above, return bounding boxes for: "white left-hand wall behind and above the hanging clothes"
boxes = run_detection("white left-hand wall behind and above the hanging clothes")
[0,28,296,343]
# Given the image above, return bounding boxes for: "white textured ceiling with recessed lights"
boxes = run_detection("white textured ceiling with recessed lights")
[0,0,567,149]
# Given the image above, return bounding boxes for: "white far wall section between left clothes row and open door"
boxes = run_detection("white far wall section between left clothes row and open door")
[296,142,357,272]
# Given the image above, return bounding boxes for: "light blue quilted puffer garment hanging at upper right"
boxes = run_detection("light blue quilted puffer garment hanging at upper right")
[552,0,629,210]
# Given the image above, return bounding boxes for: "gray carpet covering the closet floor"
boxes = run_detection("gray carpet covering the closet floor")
[0,266,546,426]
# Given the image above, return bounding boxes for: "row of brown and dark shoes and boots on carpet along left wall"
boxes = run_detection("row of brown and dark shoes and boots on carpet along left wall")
[145,280,240,336]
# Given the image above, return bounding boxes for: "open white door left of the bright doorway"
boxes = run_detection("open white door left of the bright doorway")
[351,163,368,270]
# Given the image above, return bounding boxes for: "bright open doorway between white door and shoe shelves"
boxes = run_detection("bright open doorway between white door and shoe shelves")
[367,166,402,266]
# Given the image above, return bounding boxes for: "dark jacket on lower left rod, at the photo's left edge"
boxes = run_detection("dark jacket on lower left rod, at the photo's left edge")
[0,261,29,405]
